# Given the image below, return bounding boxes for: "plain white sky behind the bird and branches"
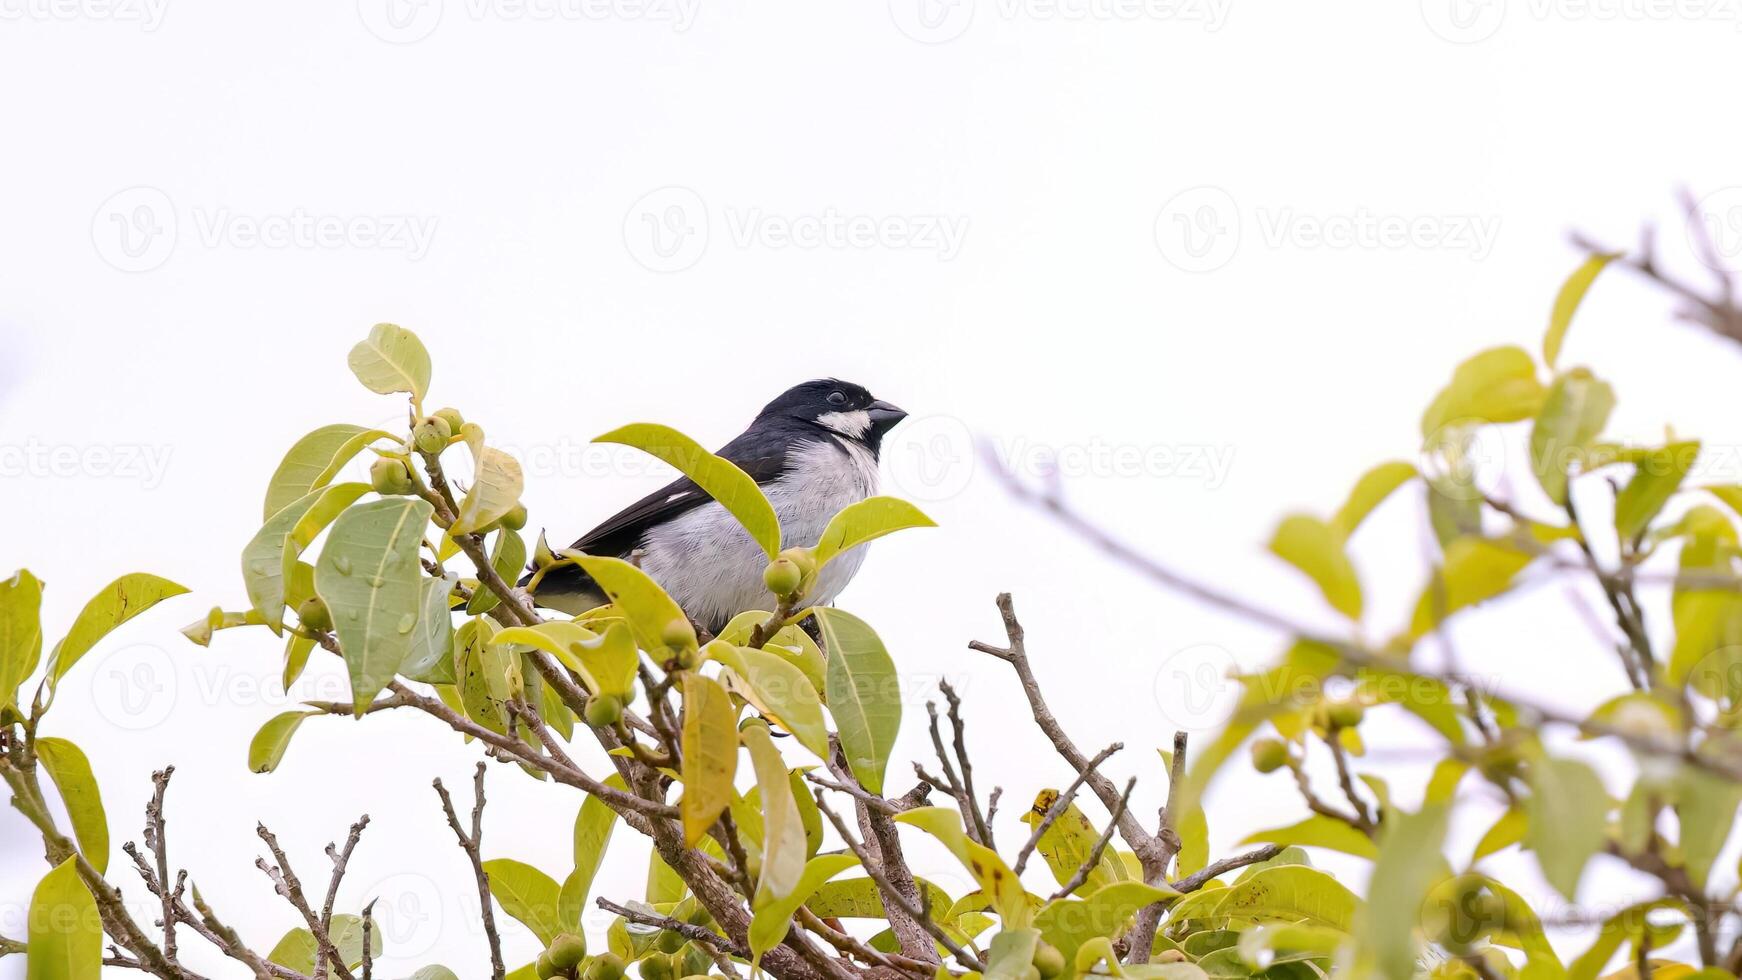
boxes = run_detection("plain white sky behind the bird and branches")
[0,0,1742,978]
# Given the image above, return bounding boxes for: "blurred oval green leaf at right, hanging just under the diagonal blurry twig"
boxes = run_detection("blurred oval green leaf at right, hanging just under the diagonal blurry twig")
[1524,755,1610,898]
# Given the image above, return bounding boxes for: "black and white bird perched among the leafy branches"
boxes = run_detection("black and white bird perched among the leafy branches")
[521,378,908,632]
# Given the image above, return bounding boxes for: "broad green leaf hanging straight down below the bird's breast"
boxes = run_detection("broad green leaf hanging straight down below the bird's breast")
[815,607,901,795]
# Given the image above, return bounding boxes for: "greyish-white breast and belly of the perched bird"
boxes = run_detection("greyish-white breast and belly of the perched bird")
[641,440,878,627]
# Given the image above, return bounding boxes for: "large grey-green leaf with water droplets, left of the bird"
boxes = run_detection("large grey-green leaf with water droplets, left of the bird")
[315,498,430,717]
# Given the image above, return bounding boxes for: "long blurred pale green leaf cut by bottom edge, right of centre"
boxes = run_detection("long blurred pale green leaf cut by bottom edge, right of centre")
[1362,806,1449,980]
